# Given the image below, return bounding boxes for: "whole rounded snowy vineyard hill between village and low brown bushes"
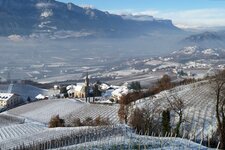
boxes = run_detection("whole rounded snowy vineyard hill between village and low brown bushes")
[7,99,119,124]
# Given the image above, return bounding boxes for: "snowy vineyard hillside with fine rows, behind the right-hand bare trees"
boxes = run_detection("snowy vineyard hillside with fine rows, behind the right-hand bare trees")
[135,81,216,140]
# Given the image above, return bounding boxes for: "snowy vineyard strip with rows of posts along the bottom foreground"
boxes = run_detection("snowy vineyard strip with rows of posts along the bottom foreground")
[0,126,207,150]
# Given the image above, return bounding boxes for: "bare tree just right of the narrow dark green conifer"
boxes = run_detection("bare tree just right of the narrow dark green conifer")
[166,95,186,136]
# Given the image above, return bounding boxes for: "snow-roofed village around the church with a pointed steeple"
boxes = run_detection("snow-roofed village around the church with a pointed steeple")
[0,73,135,110]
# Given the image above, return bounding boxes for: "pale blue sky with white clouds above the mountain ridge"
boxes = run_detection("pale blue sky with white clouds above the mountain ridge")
[59,0,225,28]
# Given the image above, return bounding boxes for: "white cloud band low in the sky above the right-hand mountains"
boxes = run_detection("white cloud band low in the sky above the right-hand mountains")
[112,8,225,28]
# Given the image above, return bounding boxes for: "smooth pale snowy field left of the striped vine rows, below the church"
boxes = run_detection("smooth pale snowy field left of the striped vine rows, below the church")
[7,99,84,123]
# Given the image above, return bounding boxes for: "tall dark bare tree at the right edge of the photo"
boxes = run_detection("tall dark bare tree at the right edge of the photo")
[211,70,225,149]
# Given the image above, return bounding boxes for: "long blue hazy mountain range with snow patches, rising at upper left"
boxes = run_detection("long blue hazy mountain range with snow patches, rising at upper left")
[0,0,180,38]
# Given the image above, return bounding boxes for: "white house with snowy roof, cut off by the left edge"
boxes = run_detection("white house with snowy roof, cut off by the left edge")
[0,93,22,108]
